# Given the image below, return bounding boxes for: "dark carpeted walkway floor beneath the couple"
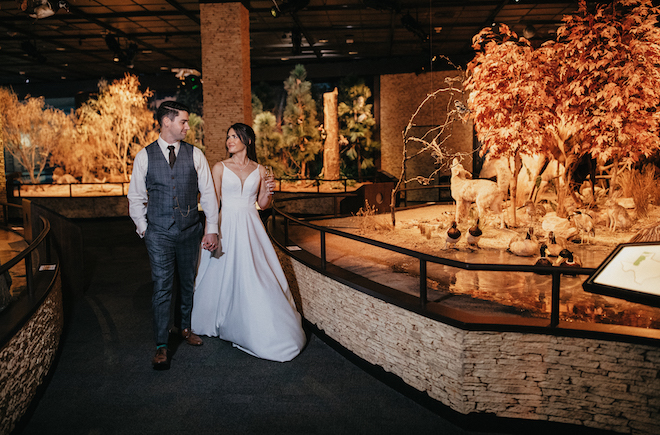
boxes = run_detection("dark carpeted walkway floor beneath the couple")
[10,219,540,435]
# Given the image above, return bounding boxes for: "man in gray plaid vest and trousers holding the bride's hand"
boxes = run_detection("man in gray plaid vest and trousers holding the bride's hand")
[128,101,218,370]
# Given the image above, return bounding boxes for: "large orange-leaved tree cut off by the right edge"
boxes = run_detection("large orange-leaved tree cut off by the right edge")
[545,0,660,200]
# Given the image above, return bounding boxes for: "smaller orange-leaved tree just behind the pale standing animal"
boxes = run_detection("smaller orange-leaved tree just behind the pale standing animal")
[463,24,557,226]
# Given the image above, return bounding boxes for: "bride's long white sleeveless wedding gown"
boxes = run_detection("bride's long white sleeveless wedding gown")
[192,166,306,361]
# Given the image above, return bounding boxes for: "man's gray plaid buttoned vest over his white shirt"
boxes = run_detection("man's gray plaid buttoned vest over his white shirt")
[147,141,199,230]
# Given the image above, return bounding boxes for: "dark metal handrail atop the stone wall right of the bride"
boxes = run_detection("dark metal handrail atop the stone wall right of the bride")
[272,199,596,328]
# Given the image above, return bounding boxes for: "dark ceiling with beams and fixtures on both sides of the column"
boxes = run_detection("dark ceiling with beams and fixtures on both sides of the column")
[0,0,577,96]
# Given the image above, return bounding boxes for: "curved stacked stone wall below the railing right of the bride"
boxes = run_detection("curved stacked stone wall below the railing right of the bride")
[280,252,660,434]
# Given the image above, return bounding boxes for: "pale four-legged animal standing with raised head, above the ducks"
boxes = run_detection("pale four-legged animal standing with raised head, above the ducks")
[451,158,504,228]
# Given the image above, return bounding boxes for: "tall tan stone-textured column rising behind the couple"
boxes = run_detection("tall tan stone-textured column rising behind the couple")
[199,2,252,166]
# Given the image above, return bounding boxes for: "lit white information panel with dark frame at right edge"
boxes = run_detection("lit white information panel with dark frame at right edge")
[582,242,660,307]
